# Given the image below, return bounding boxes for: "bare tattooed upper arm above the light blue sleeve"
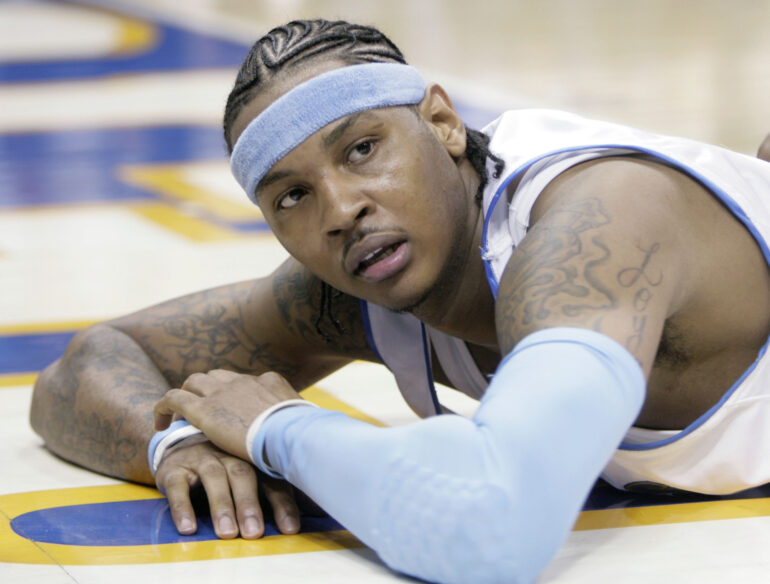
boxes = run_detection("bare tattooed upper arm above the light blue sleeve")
[496,159,696,372]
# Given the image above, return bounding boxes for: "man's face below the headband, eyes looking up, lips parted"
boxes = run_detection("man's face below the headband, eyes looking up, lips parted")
[231,65,478,310]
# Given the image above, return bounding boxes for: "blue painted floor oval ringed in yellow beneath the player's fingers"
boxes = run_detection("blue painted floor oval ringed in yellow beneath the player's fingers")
[11,499,344,546]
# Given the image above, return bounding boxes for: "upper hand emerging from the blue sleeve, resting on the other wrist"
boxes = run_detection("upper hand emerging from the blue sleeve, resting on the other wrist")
[154,369,300,460]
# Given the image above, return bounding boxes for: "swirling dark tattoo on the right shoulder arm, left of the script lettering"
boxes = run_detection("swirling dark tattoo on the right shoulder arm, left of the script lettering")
[497,199,616,352]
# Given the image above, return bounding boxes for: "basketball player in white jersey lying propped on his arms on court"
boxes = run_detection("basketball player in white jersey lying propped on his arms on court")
[32,21,770,583]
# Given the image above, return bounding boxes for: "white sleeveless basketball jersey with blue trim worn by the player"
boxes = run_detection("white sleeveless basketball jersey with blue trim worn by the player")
[362,110,770,494]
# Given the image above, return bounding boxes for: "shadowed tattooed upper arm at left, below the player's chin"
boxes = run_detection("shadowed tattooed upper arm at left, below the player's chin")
[109,259,373,388]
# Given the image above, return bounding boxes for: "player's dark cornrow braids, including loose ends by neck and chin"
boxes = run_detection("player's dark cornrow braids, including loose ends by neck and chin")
[223,20,504,338]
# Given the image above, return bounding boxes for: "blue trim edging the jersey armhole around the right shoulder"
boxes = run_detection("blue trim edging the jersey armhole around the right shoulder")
[481,144,770,450]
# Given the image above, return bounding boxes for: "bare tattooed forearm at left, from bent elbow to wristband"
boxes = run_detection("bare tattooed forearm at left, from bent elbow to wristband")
[30,325,169,484]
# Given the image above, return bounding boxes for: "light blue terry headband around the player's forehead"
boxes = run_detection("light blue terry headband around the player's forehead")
[230,63,425,203]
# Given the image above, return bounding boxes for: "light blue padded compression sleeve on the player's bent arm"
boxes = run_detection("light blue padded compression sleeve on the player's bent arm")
[253,328,645,584]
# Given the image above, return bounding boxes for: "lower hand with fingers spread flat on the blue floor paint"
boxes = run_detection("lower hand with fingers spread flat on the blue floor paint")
[155,435,300,539]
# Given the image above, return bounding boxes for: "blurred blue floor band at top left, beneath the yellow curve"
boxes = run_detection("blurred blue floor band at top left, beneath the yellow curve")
[0,3,246,83]
